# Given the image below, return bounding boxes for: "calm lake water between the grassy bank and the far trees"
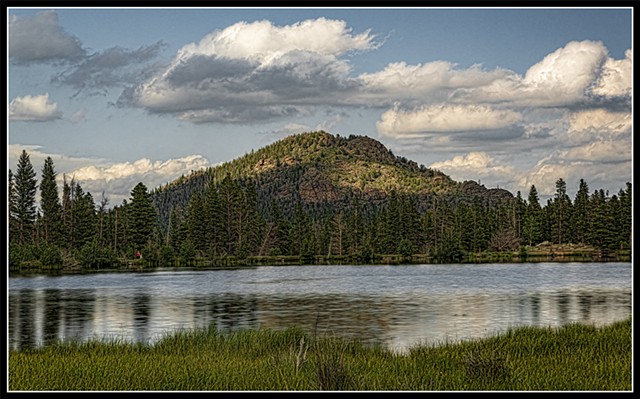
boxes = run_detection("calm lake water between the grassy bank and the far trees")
[8,263,632,351]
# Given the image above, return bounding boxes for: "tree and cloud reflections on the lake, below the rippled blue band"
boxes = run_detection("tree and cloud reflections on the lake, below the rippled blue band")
[9,268,632,350]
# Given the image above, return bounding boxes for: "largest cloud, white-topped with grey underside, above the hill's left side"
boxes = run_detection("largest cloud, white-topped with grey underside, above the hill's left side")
[119,18,377,123]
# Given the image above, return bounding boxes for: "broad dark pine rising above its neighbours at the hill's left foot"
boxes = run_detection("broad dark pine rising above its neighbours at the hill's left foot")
[128,182,157,249]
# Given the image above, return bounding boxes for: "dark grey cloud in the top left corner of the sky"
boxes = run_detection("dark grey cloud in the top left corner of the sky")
[8,11,85,64]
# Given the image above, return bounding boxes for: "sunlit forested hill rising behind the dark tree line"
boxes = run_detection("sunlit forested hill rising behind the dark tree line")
[152,131,513,228]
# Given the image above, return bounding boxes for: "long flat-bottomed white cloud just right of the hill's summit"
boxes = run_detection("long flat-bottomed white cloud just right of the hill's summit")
[376,104,521,137]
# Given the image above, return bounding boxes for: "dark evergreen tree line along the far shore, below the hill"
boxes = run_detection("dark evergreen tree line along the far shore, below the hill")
[8,151,632,269]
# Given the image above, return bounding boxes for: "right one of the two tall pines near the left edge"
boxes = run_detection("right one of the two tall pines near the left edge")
[40,157,62,244]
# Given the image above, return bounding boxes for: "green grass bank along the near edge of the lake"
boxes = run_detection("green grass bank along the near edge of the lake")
[9,318,632,391]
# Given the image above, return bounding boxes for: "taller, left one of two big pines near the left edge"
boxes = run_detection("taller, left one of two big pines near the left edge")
[12,150,38,244]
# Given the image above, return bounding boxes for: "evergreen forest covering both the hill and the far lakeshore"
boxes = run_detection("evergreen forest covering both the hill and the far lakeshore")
[8,132,632,270]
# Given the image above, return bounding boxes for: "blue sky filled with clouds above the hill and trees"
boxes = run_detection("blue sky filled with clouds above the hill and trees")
[5,7,633,206]
